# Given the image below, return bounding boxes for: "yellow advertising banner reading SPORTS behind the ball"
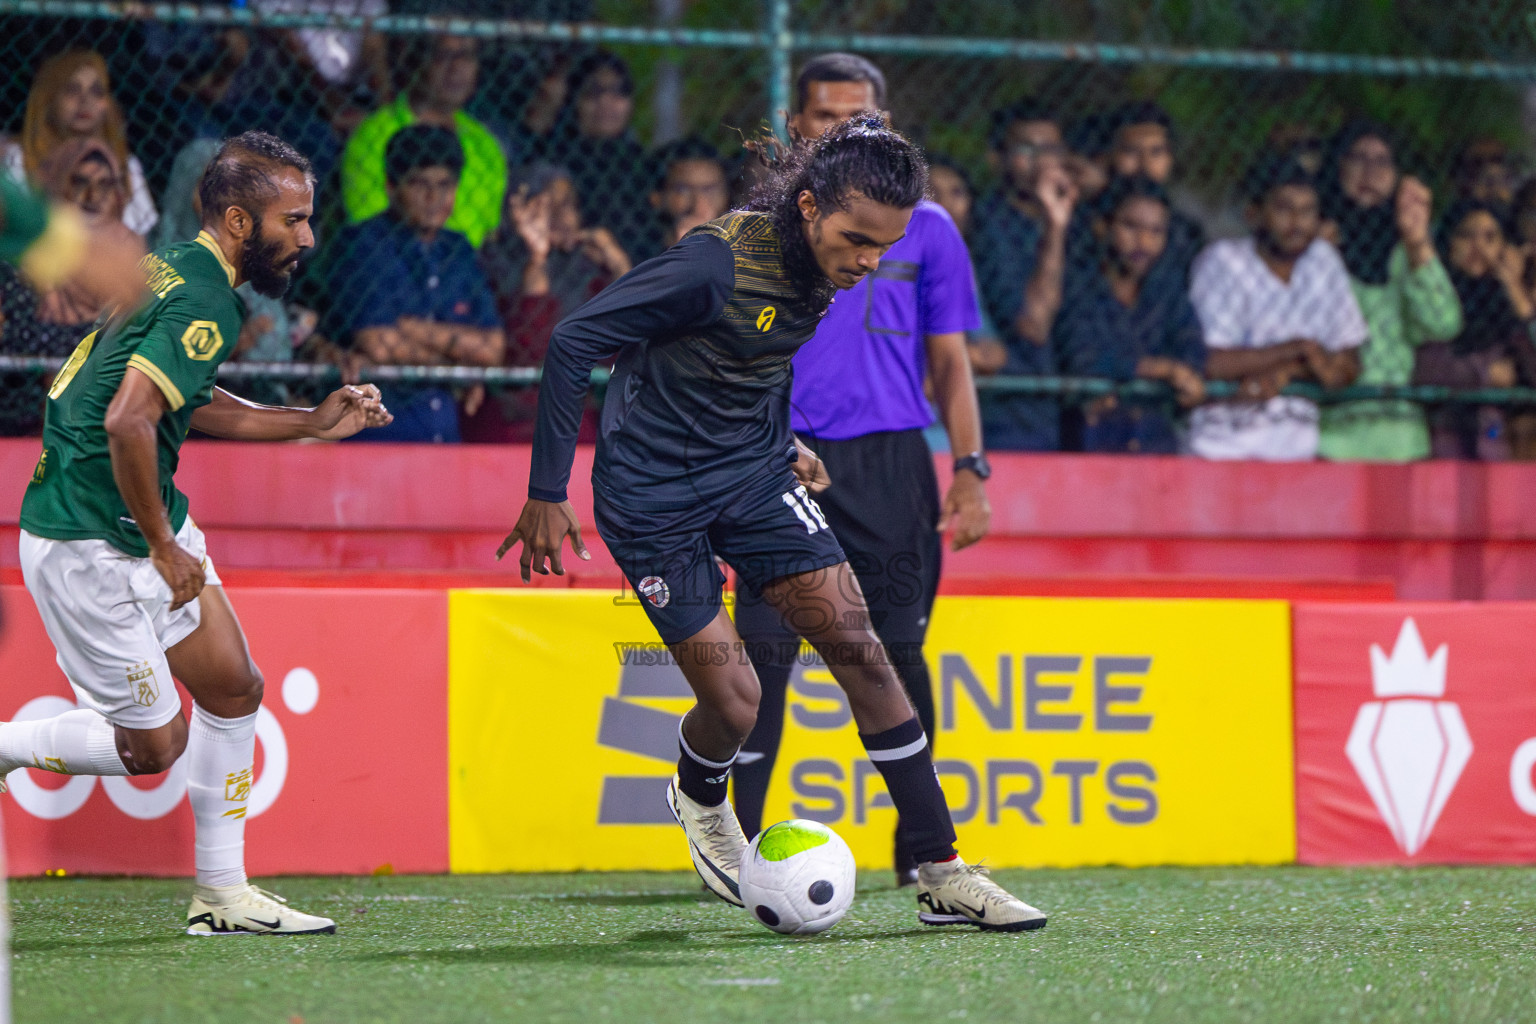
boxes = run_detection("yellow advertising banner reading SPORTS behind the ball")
[449,590,1296,872]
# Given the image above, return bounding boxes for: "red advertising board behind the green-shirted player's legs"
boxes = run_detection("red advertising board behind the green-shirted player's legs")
[0,585,449,875]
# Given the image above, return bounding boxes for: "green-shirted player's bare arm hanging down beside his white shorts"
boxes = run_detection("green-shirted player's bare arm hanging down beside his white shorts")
[106,367,203,611]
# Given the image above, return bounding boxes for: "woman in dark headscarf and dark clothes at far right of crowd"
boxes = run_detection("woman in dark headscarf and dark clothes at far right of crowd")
[1413,200,1536,461]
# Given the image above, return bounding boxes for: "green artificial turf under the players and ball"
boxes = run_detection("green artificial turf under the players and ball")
[11,867,1536,1024]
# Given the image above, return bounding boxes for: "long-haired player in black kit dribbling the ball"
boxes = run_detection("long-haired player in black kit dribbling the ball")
[498,114,1046,932]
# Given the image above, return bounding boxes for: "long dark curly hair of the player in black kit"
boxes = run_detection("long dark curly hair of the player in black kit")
[746,111,928,309]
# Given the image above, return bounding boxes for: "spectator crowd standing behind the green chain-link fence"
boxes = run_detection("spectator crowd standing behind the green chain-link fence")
[0,23,1536,461]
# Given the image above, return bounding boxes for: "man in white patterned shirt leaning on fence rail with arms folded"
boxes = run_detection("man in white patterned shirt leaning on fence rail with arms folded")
[1189,154,1369,462]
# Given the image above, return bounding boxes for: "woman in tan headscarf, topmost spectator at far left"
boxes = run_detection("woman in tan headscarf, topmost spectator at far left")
[3,49,160,236]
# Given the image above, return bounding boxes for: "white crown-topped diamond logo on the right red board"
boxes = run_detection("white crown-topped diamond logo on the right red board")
[1344,619,1471,857]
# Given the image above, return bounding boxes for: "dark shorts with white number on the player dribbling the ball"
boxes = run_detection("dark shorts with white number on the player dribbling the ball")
[593,485,848,643]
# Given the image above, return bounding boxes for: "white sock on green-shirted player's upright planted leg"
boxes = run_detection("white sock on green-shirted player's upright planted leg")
[186,703,257,889]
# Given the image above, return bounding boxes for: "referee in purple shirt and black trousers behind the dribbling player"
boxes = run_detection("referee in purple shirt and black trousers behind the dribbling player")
[734,54,992,884]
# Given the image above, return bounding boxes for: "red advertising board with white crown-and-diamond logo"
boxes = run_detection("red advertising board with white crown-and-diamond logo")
[1293,603,1536,864]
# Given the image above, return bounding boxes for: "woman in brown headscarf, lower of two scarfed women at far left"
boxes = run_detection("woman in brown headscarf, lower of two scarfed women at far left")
[0,138,144,436]
